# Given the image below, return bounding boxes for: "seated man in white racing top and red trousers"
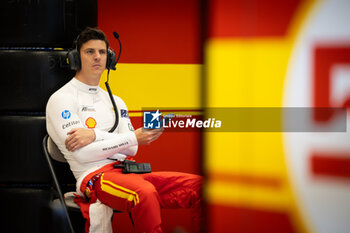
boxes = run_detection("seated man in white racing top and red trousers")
[46,28,202,233]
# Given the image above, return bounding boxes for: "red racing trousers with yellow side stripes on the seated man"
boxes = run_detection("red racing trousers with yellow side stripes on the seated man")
[77,162,203,233]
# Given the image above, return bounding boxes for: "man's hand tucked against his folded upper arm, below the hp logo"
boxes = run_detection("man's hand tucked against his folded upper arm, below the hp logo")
[64,128,96,152]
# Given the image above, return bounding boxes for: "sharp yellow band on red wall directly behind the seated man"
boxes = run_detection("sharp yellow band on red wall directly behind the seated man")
[100,63,201,110]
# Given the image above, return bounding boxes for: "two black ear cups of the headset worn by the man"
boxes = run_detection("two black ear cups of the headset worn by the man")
[67,42,116,70]
